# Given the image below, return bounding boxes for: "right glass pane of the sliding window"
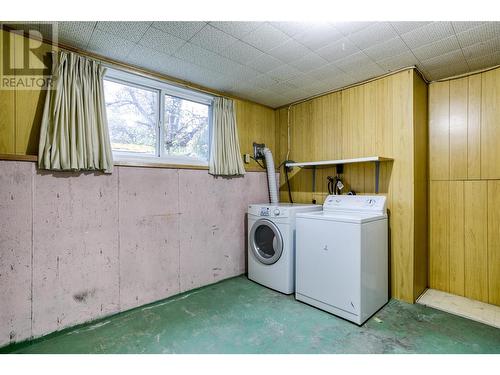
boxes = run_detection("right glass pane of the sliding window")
[163,95,209,161]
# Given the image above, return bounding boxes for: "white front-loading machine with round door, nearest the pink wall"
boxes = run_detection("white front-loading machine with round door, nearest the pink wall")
[248,203,322,294]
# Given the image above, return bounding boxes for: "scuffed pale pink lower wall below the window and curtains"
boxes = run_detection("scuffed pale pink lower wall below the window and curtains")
[0,161,268,346]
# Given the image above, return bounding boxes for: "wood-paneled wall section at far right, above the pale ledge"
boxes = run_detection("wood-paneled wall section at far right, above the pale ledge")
[429,69,500,305]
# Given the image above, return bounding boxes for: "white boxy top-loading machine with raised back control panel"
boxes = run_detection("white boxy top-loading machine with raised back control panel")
[295,195,389,325]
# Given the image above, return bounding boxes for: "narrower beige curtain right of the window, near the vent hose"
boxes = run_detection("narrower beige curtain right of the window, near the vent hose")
[208,98,245,176]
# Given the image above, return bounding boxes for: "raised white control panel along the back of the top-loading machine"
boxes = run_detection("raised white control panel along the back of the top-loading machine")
[323,195,386,214]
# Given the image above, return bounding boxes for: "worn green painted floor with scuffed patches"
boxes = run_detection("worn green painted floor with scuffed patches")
[0,276,500,353]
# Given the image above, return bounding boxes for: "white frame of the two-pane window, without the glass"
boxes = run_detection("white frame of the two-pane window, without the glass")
[103,67,214,167]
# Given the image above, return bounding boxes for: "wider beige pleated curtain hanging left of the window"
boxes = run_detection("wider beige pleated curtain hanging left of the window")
[38,52,113,173]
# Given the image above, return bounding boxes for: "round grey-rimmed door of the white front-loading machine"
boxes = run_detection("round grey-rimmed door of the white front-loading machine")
[250,219,283,264]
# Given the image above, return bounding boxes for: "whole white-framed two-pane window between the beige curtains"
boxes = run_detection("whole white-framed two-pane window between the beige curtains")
[104,69,212,165]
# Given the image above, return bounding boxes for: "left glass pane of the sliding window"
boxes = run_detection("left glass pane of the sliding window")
[104,80,158,155]
